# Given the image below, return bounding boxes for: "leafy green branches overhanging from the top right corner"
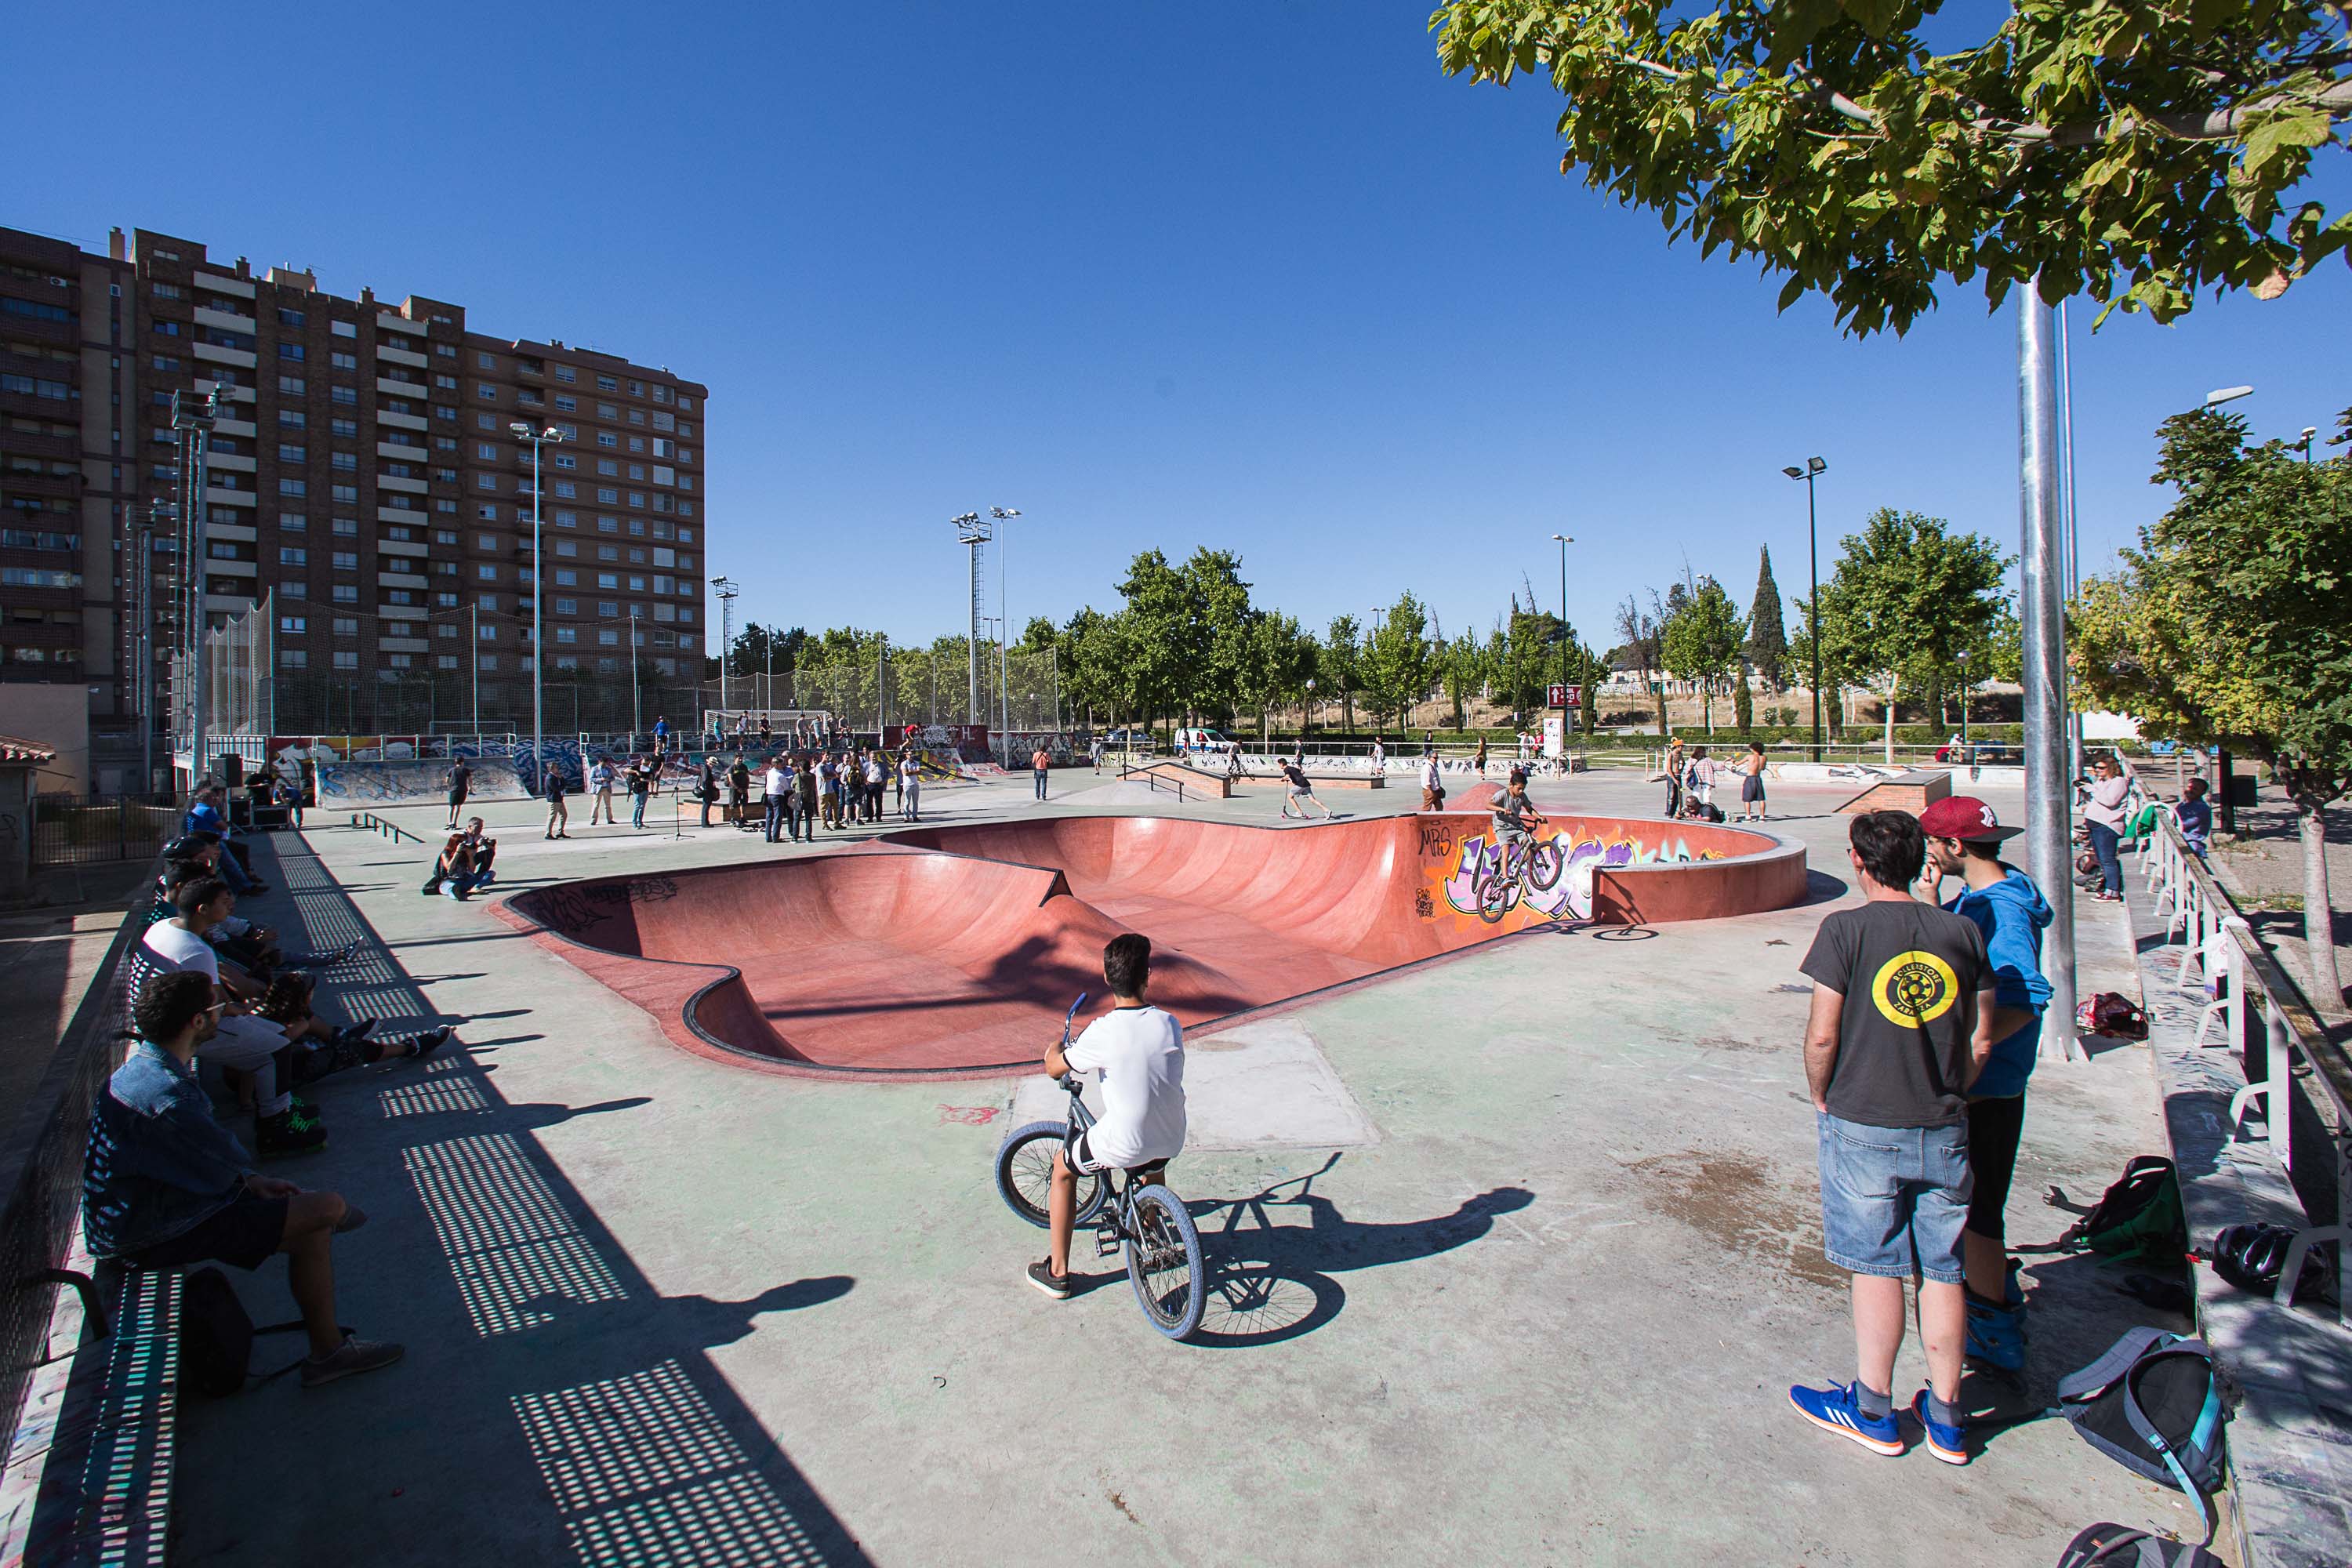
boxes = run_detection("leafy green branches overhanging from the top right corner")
[1430,0,2352,334]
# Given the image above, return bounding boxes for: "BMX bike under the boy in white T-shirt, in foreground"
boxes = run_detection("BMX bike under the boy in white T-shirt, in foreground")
[997,994,1207,1340]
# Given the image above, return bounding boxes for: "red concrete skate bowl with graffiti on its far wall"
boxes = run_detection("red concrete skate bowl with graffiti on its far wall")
[494,813,1806,1076]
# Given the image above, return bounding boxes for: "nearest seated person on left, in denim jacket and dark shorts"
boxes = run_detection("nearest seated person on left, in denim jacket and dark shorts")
[82,971,402,1389]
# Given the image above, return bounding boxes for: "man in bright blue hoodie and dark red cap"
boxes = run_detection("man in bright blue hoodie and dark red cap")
[1919,794,2051,1373]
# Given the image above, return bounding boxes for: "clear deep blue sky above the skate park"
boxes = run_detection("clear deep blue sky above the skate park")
[0,0,2352,644]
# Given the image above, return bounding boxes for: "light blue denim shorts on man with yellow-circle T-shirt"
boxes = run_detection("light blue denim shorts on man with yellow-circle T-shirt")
[1813,1112,1973,1286]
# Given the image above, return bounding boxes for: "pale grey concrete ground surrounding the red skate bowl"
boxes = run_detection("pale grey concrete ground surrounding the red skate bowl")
[174,769,2197,1566]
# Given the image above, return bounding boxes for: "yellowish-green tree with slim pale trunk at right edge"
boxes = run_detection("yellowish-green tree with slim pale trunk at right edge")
[2067,409,2352,1013]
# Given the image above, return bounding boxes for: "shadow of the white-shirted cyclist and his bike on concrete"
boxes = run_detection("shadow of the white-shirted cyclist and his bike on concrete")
[1185,1152,1536,1349]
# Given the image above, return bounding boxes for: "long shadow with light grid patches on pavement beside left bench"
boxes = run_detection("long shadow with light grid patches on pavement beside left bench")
[174,837,868,1568]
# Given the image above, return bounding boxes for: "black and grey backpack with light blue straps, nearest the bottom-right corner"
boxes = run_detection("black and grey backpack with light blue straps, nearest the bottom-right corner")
[2053,1328,2227,1540]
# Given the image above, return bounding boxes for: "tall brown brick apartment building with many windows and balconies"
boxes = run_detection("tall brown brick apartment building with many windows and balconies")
[0,228,708,787]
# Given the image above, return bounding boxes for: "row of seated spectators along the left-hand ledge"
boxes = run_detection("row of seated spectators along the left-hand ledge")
[82,787,449,1387]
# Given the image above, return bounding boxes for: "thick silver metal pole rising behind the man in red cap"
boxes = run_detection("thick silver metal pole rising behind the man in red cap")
[2018,285,2074,1060]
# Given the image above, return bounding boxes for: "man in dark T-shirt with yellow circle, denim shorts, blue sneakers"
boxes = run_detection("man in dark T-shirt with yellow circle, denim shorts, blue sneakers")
[1788,811,1999,1465]
